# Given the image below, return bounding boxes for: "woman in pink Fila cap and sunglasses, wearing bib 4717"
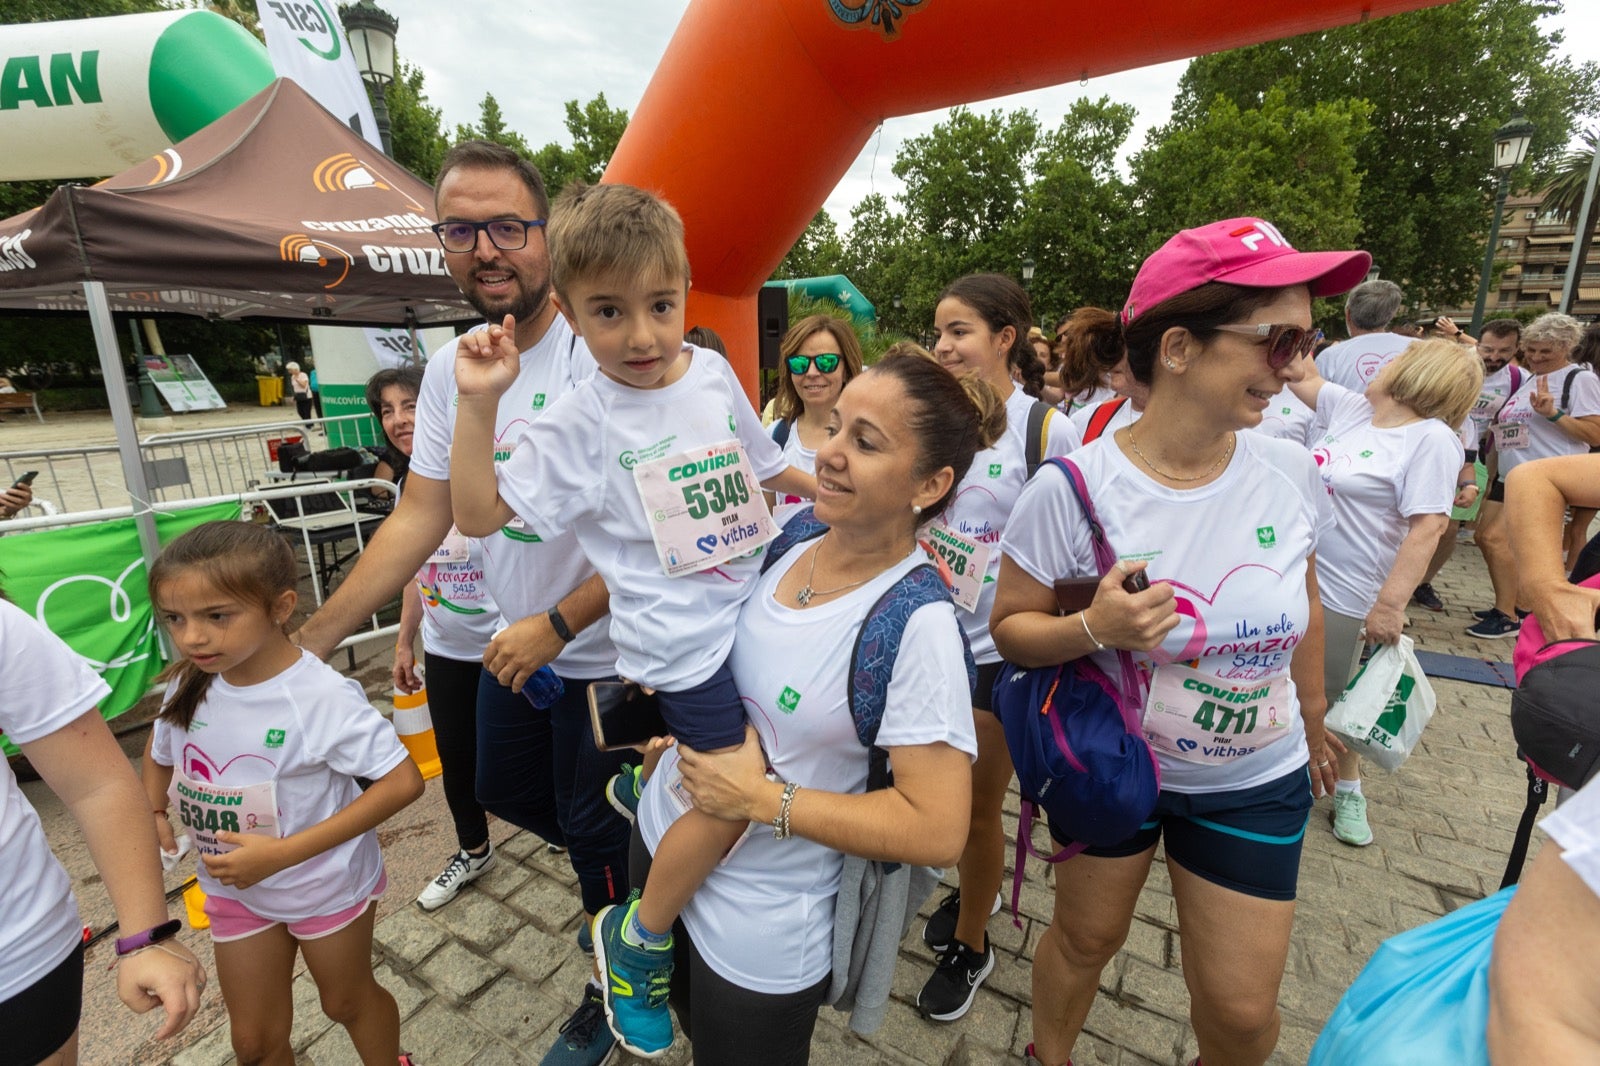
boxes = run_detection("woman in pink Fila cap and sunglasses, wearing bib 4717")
[992,218,1371,1066]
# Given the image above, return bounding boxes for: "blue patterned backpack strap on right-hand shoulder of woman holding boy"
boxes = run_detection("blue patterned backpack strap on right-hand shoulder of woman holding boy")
[850,563,978,792]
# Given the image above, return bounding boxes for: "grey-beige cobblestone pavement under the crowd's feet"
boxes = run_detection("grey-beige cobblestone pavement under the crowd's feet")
[112,534,1525,1066]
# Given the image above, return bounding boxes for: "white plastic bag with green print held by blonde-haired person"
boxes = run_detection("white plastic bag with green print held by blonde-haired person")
[1326,637,1437,770]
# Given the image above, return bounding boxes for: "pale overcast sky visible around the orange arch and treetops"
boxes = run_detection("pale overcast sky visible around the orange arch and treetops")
[368,0,1600,219]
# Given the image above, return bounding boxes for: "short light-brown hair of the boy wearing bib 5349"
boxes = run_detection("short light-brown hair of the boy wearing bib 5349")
[546,181,690,299]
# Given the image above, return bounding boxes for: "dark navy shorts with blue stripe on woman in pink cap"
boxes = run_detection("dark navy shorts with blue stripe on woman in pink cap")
[1050,767,1312,900]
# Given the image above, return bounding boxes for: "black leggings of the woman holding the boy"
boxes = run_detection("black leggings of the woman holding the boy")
[629,826,830,1066]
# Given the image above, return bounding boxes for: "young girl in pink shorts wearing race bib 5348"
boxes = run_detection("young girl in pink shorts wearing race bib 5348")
[142,522,422,1066]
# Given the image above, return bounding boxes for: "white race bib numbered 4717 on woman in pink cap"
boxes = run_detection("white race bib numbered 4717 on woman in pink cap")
[1144,663,1294,765]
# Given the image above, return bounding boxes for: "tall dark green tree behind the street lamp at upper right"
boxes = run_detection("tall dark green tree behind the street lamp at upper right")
[1166,0,1600,307]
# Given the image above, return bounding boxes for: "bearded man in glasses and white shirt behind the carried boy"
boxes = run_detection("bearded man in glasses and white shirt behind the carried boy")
[299,141,630,1066]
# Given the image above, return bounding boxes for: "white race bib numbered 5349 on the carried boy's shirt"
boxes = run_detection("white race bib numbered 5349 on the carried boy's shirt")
[634,440,778,578]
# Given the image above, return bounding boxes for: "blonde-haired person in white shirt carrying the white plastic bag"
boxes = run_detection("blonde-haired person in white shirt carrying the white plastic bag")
[1290,339,1483,847]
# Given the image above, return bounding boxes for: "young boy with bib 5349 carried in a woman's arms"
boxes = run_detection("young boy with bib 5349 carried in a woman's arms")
[450,178,816,1058]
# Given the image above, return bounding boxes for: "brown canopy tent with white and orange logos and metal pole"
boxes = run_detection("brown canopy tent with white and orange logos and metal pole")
[0,78,477,560]
